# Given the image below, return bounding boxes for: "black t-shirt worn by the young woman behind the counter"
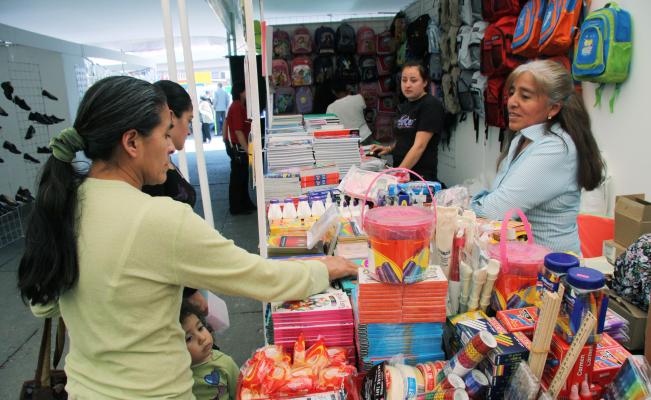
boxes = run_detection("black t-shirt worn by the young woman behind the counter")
[393,94,444,180]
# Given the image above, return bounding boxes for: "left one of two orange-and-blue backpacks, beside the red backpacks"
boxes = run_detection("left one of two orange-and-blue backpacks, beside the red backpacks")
[513,0,547,57]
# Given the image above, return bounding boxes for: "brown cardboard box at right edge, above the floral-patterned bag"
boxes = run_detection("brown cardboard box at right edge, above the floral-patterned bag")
[615,194,651,247]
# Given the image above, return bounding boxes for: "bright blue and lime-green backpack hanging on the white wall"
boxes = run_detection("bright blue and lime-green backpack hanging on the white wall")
[572,3,633,112]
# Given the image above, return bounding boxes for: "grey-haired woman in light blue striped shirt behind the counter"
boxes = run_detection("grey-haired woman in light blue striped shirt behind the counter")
[471,60,604,254]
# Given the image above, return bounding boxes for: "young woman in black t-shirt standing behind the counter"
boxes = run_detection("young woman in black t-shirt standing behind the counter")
[371,62,444,181]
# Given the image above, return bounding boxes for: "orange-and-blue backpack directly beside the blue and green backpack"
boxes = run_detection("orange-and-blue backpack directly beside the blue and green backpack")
[538,0,583,56]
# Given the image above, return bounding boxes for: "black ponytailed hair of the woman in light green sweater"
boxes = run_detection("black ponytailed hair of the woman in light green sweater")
[18,76,166,305]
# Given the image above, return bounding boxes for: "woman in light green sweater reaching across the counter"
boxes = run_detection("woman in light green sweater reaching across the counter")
[18,76,356,400]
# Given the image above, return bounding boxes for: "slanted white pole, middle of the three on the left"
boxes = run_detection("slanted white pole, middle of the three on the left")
[177,0,215,228]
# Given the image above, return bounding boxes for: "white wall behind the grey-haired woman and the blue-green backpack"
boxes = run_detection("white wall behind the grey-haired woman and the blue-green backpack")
[439,0,651,211]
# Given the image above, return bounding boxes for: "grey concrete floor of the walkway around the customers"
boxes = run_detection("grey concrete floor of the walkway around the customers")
[0,138,264,399]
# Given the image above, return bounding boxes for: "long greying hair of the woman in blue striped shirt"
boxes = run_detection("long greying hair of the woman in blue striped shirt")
[498,60,604,190]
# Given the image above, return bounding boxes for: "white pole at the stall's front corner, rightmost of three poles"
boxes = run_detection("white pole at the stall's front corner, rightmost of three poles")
[244,0,267,257]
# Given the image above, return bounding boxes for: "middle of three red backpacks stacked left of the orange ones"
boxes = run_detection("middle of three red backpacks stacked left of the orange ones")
[481,17,522,78]
